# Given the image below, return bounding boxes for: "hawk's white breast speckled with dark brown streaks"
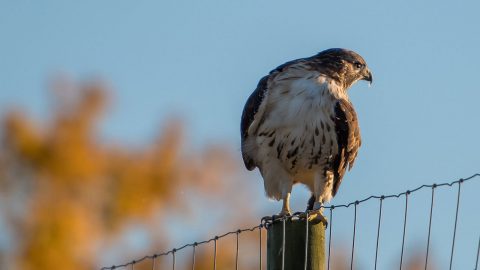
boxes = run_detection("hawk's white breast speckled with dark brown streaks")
[256,72,342,176]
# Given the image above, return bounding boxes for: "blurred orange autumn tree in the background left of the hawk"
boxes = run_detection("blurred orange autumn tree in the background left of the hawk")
[0,81,255,269]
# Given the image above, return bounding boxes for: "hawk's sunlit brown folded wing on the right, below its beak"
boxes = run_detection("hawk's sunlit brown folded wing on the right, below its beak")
[332,99,362,196]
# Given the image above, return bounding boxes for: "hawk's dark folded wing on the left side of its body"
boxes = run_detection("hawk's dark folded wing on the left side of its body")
[240,58,307,170]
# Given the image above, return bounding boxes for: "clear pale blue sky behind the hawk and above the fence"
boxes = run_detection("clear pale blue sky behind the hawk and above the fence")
[0,0,480,269]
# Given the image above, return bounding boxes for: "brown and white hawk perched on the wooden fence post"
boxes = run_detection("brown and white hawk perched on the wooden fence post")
[241,48,372,223]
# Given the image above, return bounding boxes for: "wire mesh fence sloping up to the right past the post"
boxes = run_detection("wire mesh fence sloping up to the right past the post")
[101,173,480,270]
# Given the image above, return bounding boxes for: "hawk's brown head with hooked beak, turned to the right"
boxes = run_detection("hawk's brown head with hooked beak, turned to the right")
[312,48,373,89]
